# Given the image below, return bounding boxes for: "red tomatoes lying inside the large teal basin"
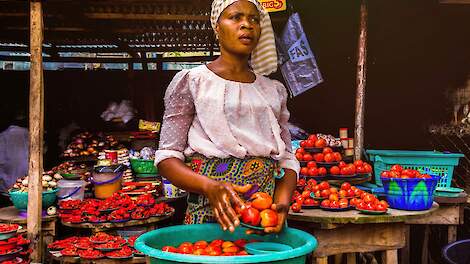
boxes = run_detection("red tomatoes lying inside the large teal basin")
[162,239,256,256]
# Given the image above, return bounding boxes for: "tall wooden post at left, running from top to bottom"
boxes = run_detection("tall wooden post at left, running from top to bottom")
[27,0,44,263]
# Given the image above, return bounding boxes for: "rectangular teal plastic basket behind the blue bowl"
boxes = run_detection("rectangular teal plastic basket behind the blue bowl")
[366,150,464,187]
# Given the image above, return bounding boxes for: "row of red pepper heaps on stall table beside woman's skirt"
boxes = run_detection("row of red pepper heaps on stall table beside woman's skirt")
[59,193,174,223]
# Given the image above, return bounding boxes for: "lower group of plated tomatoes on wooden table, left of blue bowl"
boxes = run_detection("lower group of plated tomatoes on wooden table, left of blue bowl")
[291,179,388,214]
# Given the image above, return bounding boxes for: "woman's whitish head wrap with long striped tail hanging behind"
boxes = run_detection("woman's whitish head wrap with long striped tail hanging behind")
[211,0,277,75]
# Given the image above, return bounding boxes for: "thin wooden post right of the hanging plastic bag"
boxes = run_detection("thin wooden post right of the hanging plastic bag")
[354,0,367,159]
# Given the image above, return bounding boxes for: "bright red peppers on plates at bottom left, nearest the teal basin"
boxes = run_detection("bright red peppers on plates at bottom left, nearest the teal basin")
[47,232,139,259]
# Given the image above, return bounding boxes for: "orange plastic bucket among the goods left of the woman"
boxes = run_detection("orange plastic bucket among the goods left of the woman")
[90,165,124,199]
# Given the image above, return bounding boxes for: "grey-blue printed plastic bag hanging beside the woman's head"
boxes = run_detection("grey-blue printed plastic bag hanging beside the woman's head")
[278,13,323,96]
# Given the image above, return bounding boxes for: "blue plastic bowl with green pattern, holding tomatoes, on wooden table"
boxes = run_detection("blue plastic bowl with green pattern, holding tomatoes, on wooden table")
[382,176,439,211]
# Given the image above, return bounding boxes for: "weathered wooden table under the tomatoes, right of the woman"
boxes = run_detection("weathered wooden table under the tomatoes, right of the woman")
[288,203,439,264]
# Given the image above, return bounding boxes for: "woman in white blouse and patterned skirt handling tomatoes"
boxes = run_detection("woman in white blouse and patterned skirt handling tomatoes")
[155,0,299,233]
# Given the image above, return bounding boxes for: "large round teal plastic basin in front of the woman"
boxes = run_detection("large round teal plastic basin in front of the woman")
[134,224,318,264]
